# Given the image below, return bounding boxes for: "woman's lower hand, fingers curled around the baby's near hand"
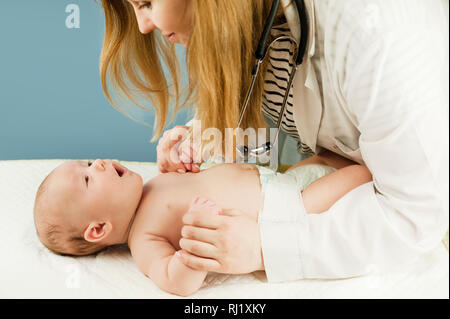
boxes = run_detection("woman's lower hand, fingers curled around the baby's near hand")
[180,200,264,274]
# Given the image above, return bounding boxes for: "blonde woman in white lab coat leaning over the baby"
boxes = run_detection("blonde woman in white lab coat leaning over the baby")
[101,0,448,281]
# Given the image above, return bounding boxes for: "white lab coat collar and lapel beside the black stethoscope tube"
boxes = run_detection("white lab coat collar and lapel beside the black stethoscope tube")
[281,0,322,152]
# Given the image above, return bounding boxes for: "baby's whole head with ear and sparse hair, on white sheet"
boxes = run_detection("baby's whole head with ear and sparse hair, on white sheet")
[34,160,142,256]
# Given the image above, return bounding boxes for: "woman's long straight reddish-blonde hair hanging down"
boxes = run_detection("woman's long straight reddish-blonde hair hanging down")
[100,0,283,150]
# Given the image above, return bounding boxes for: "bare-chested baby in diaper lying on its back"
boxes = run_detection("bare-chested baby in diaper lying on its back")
[34,154,371,296]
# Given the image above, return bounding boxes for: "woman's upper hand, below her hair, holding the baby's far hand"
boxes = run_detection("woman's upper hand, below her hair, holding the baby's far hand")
[156,126,200,173]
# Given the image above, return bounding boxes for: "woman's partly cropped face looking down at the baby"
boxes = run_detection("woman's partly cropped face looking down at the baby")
[127,0,193,47]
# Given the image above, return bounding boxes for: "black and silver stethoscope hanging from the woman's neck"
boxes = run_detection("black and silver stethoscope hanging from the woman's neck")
[236,0,309,159]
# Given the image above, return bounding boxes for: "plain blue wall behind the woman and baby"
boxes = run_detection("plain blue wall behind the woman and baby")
[0,0,187,161]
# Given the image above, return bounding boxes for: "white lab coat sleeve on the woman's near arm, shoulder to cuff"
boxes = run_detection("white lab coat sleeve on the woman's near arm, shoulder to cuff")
[260,22,449,282]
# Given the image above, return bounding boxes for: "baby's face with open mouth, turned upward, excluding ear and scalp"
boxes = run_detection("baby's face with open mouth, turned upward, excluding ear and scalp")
[51,160,142,228]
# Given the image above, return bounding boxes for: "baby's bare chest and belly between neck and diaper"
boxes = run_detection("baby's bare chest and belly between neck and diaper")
[136,164,263,250]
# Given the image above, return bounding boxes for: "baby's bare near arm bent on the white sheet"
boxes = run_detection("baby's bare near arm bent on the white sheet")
[130,234,208,296]
